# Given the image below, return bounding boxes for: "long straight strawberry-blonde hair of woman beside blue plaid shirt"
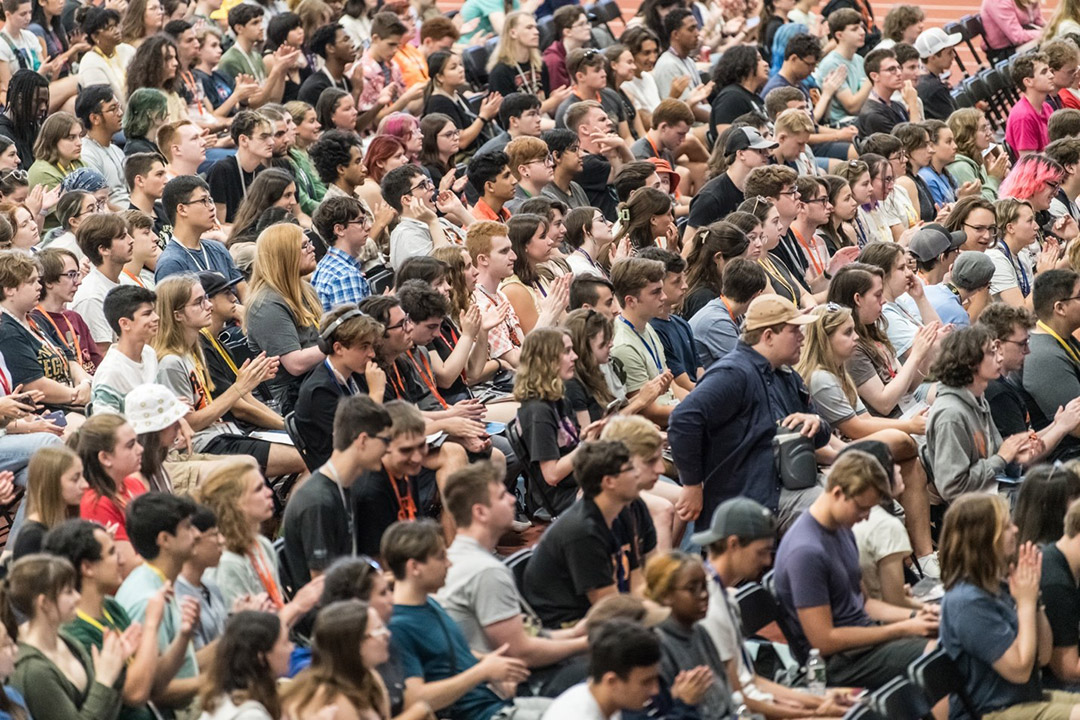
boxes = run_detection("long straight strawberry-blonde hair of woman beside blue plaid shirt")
[244,222,323,332]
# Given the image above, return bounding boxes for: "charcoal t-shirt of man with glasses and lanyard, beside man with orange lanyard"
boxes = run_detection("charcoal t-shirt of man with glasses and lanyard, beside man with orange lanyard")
[282,472,353,586]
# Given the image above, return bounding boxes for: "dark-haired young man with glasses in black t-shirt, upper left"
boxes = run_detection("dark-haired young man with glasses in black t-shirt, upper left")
[206,109,273,223]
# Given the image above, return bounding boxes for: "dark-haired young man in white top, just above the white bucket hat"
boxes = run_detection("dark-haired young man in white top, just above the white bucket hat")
[90,285,158,413]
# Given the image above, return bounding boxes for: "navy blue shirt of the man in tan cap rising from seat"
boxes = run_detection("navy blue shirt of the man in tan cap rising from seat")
[667,341,832,519]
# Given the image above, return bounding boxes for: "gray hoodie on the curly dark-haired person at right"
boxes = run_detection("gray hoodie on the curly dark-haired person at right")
[927,384,1005,502]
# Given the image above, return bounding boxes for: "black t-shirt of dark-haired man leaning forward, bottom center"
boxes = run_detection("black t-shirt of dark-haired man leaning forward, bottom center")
[522,498,627,627]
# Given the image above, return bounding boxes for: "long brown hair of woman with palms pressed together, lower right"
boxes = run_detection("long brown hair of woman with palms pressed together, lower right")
[937,492,1012,595]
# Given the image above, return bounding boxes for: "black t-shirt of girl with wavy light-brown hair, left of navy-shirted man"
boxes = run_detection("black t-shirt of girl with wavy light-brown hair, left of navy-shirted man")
[517,397,580,515]
